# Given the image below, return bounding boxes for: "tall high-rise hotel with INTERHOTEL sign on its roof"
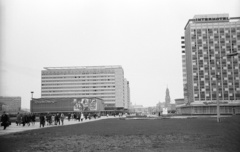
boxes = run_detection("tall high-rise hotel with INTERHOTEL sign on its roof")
[182,14,240,114]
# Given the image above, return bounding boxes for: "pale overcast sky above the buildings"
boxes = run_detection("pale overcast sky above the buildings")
[0,0,240,108]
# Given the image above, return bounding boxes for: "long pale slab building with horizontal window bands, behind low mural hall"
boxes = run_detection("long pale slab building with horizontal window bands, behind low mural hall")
[41,66,129,108]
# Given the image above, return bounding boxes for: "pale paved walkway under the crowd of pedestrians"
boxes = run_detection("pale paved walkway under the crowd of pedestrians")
[0,116,118,136]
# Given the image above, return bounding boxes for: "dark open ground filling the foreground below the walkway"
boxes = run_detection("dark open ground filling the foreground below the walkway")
[0,116,240,152]
